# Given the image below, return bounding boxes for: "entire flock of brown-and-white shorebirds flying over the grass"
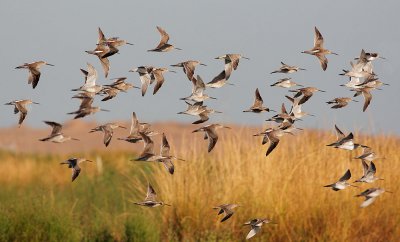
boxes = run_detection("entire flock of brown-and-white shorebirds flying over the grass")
[6,27,388,239]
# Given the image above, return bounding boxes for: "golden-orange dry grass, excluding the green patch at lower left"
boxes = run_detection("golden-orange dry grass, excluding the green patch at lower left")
[0,125,400,241]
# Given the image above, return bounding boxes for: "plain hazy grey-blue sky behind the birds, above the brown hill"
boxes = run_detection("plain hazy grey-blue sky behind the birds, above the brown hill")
[0,0,400,134]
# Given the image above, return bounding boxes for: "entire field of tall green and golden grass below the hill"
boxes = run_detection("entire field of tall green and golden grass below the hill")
[0,128,400,241]
